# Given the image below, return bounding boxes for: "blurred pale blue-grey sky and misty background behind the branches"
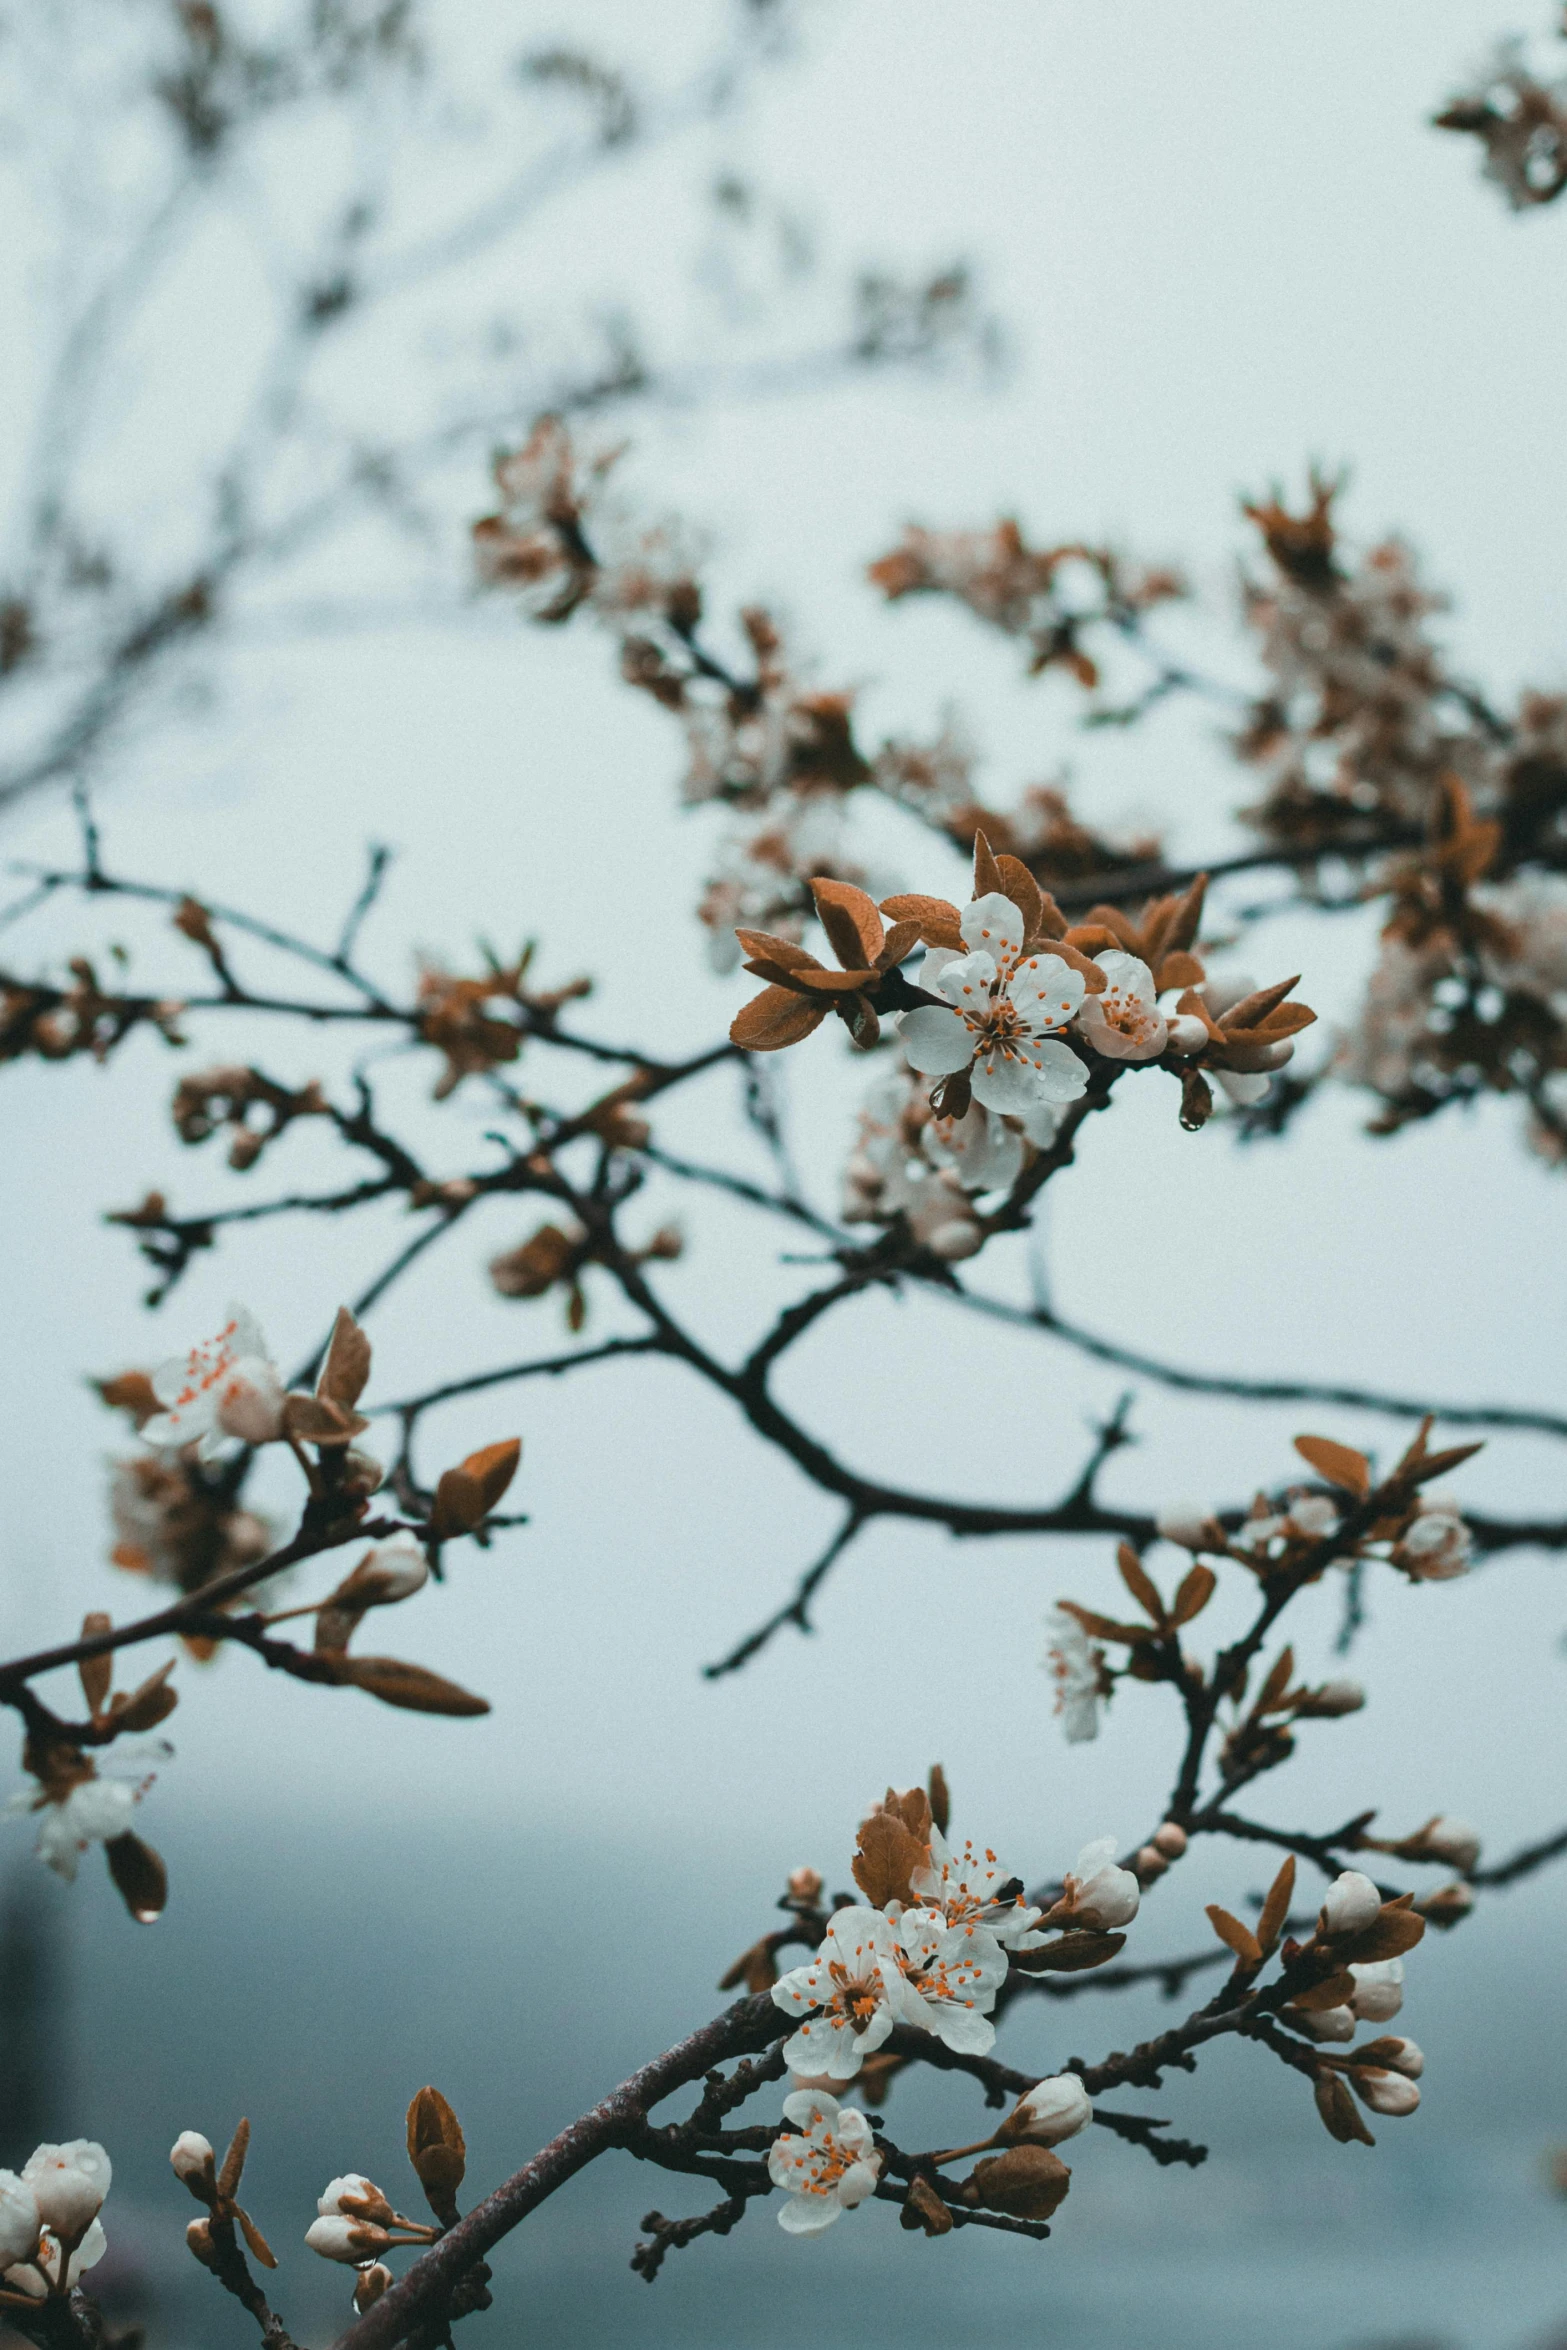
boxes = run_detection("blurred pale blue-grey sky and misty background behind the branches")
[0,0,1567,2350]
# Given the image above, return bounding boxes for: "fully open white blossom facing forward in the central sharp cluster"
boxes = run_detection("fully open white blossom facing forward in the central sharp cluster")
[897,891,1088,1112]
